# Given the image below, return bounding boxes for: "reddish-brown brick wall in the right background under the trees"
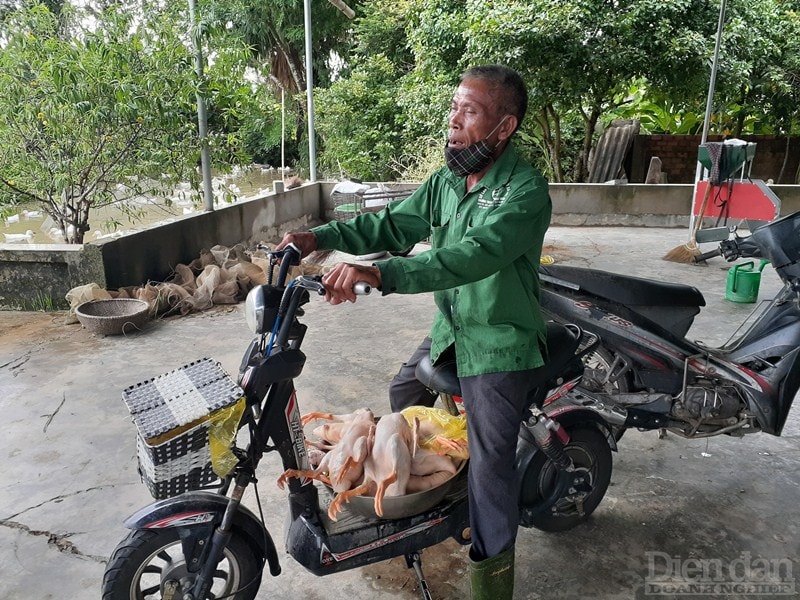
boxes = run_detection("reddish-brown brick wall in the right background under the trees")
[629,135,800,184]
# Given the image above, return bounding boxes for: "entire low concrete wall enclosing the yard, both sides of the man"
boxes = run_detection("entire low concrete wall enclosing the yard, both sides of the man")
[0,182,800,309]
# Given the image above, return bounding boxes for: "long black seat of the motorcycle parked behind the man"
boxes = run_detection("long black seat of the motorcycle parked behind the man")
[539,265,706,307]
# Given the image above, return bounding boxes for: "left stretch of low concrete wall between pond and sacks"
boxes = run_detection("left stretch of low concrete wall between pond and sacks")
[0,184,322,310]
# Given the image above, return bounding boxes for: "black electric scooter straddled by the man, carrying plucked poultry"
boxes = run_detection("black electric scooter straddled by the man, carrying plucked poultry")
[102,246,616,600]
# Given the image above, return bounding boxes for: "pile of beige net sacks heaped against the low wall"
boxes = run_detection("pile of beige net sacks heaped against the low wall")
[66,244,322,323]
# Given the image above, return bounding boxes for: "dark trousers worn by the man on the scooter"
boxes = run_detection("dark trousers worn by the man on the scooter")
[389,338,535,560]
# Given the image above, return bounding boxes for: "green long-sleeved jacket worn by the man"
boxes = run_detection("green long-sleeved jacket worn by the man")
[312,144,551,377]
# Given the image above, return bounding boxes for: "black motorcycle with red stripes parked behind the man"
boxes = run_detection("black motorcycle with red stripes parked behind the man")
[540,212,800,440]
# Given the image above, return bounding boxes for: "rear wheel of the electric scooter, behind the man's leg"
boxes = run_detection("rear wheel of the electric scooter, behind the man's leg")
[520,426,613,532]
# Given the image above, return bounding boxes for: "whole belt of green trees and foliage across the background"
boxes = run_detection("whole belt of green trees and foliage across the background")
[6,0,800,204]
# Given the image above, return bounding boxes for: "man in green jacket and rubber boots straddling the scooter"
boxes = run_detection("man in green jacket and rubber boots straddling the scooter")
[279,65,551,600]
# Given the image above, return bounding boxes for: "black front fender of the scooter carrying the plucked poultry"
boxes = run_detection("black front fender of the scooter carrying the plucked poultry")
[120,491,281,576]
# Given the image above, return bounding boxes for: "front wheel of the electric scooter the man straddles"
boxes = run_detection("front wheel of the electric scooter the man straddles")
[103,529,264,600]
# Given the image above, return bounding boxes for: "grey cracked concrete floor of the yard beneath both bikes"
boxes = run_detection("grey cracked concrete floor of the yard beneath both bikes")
[0,228,800,600]
